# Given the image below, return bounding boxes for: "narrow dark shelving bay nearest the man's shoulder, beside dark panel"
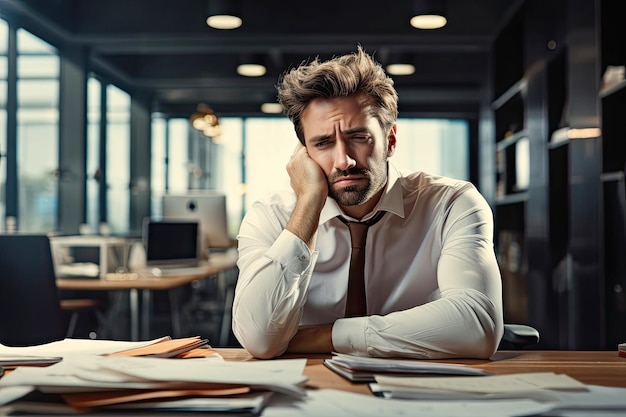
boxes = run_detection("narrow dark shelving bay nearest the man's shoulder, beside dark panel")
[490,1,529,323]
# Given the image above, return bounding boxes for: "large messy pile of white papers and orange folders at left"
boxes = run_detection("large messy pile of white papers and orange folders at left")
[0,337,307,415]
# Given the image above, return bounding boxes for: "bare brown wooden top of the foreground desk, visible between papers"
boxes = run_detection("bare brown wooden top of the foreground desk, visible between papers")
[216,349,626,395]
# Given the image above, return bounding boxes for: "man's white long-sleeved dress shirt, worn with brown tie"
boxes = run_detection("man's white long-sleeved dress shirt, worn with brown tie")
[233,165,503,359]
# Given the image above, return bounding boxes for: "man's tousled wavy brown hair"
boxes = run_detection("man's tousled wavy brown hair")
[276,45,398,144]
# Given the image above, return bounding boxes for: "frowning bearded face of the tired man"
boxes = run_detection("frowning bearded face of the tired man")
[301,93,396,214]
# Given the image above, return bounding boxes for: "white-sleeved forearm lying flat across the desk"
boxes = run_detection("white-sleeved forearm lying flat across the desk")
[332,290,502,359]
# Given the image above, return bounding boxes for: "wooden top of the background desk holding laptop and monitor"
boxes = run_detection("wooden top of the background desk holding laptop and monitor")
[56,251,237,291]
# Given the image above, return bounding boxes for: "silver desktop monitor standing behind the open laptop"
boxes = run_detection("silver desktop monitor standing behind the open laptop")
[163,190,232,249]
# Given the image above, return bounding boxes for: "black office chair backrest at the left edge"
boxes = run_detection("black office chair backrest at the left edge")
[0,234,67,346]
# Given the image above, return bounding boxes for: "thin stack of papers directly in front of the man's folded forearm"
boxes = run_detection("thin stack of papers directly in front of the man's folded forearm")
[324,353,486,382]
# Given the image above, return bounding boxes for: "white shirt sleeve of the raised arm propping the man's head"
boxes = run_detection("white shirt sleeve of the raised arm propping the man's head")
[233,201,317,358]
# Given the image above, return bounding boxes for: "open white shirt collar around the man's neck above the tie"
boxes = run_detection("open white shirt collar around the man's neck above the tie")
[319,163,404,225]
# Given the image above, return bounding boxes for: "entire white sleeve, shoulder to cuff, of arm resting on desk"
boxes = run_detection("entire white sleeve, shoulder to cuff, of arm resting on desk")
[332,185,503,359]
